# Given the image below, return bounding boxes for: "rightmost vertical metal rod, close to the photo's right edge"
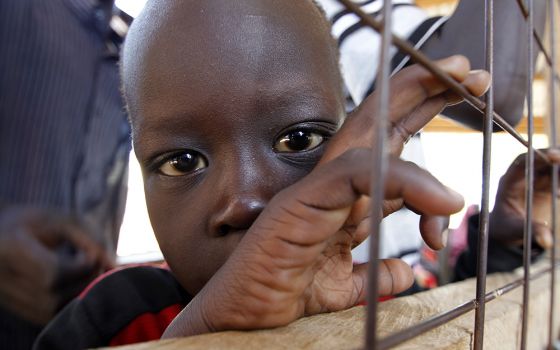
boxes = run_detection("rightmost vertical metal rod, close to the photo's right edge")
[548,0,558,350]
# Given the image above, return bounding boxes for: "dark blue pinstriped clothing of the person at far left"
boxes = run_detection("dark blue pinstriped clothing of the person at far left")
[0,0,130,349]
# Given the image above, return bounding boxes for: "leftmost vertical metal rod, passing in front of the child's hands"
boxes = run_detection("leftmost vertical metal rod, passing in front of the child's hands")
[366,0,392,350]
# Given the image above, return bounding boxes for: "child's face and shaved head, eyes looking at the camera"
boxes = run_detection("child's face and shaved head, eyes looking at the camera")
[123,0,344,294]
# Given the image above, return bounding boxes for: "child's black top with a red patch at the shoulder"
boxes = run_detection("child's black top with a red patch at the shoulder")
[34,266,191,350]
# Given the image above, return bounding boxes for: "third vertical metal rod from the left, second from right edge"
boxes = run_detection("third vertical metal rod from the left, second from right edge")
[521,0,534,350]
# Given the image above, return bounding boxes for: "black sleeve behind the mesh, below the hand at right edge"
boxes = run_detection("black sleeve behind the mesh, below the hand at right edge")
[455,214,544,280]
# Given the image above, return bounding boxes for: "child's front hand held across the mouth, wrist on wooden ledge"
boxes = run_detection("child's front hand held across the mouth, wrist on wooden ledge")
[165,149,463,337]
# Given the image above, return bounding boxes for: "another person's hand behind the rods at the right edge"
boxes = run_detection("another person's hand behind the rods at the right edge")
[489,149,560,249]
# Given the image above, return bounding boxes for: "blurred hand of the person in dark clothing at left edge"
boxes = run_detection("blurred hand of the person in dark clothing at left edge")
[0,207,112,325]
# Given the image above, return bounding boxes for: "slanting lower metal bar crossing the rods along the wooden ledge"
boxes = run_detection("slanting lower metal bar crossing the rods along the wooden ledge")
[378,264,558,350]
